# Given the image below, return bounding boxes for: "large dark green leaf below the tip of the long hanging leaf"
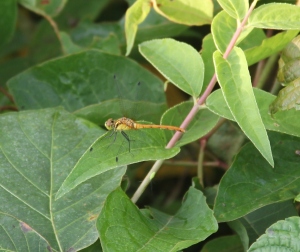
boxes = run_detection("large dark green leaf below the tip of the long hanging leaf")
[214,132,300,222]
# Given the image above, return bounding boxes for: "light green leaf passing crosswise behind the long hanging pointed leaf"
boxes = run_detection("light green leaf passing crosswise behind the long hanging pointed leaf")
[206,88,300,137]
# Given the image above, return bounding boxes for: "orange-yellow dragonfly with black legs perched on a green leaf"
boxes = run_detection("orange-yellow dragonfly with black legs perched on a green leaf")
[104,76,185,162]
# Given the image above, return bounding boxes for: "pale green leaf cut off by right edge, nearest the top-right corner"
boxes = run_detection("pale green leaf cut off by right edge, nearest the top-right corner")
[248,3,300,30]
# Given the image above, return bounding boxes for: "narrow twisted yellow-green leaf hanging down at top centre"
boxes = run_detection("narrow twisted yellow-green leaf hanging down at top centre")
[125,0,151,56]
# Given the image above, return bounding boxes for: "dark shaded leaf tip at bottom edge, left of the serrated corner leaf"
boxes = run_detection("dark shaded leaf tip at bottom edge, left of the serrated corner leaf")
[201,235,243,252]
